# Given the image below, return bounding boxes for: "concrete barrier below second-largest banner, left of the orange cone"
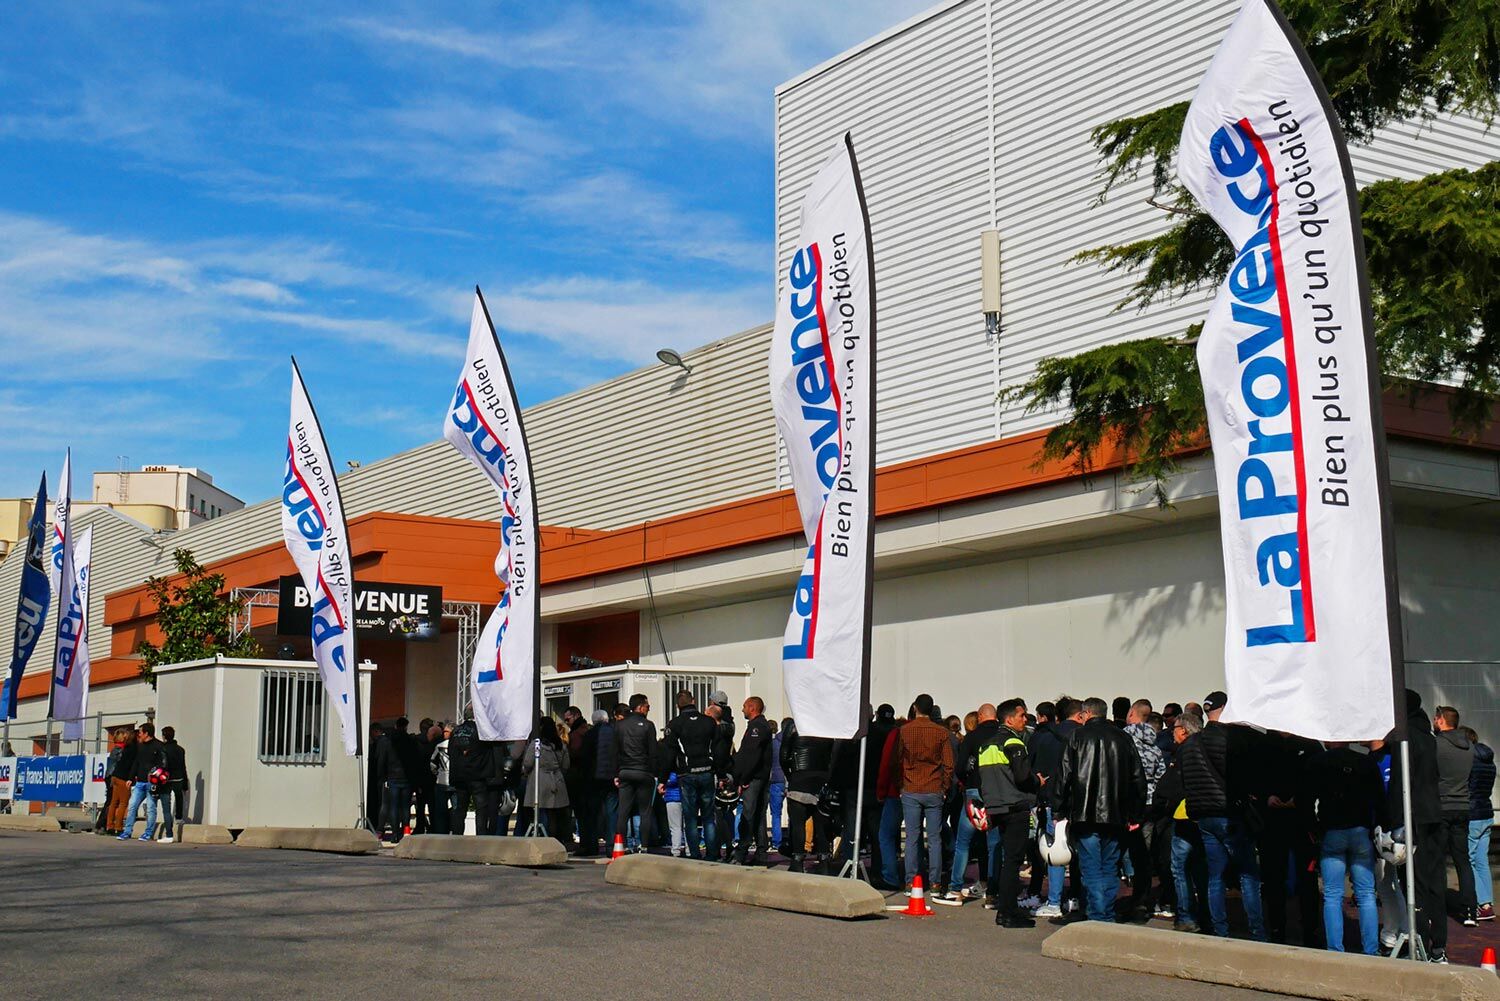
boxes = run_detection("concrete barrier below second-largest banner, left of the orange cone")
[605,854,885,918]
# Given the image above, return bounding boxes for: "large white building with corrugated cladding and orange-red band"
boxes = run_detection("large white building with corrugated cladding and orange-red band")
[0,0,1500,816]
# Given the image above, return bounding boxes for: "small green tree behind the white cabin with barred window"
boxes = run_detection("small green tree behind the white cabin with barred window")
[137,549,261,689]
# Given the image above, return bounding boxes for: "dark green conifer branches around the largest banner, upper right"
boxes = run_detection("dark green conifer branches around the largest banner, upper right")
[1007,0,1500,503]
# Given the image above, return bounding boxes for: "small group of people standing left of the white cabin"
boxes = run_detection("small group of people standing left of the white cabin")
[95,722,188,845]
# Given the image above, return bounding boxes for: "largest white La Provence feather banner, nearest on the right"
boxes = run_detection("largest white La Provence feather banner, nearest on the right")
[1178,0,1404,740]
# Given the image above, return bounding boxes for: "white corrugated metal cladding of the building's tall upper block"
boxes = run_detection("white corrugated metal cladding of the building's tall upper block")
[776,0,1500,464]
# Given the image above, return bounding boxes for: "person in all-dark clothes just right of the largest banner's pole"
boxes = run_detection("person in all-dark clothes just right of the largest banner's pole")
[1385,689,1448,959]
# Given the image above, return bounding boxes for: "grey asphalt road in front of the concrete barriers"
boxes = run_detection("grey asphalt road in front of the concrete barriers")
[0,831,1269,1001]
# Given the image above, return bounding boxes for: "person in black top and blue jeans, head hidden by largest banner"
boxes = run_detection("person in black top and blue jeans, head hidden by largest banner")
[1298,741,1386,956]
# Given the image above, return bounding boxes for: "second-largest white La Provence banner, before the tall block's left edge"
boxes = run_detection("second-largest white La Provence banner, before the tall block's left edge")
[771,135,875,738]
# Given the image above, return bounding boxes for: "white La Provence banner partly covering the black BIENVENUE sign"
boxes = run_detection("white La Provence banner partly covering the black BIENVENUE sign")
[282,359,360,755]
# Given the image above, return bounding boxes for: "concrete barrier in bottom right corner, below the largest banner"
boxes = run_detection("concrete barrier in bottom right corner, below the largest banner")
[1041,921,1500,1001]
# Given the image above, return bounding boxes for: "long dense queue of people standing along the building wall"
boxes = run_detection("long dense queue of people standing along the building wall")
[372,690,1496,960]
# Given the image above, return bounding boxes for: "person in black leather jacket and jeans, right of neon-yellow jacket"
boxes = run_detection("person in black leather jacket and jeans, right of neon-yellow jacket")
[1058,698,1146,921]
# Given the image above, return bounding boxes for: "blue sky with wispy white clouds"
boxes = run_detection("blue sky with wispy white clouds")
[0,0,930,501]
